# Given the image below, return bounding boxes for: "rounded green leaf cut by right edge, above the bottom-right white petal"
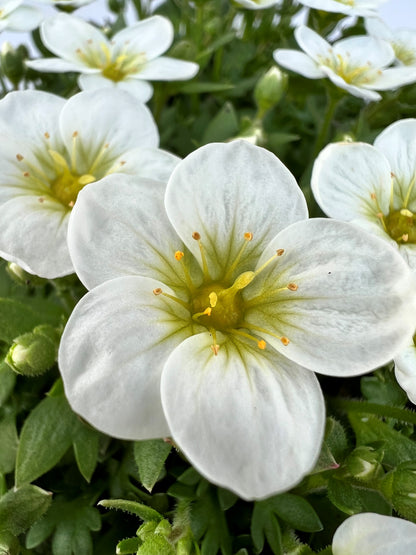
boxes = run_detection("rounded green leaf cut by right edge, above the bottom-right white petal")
[381,461,416,522]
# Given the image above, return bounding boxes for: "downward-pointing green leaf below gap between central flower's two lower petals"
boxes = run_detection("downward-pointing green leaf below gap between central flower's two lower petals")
[134,439,172,491]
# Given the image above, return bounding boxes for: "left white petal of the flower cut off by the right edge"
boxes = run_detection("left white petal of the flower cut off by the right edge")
[311,143,391,225]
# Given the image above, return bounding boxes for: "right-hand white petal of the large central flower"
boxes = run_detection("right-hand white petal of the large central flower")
[244,218,416,376]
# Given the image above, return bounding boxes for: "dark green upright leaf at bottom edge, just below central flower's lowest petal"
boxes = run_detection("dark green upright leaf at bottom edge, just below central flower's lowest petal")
[250,500,283,555]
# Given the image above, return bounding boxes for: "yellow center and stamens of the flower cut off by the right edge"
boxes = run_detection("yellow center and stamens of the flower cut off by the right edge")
[371,174,416,244]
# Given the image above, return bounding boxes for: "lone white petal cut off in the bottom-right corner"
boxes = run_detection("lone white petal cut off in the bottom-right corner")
[332,513,416,555]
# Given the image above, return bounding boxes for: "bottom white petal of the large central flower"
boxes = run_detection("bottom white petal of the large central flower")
[161,333,325,500]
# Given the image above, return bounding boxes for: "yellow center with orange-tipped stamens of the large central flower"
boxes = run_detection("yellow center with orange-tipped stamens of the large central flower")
[153,232,298,355]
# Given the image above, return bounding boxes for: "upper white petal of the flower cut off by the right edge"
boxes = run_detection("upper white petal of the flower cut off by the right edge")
[374,119,416,212]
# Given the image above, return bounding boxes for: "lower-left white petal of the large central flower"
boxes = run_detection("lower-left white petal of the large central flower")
[59,277,189,440]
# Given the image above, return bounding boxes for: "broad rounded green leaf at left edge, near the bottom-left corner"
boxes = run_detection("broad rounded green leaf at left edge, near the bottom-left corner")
[0,484,52,536]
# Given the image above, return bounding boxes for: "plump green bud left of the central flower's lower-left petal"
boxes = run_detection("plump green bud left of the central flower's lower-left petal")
[5,324,59,376]
